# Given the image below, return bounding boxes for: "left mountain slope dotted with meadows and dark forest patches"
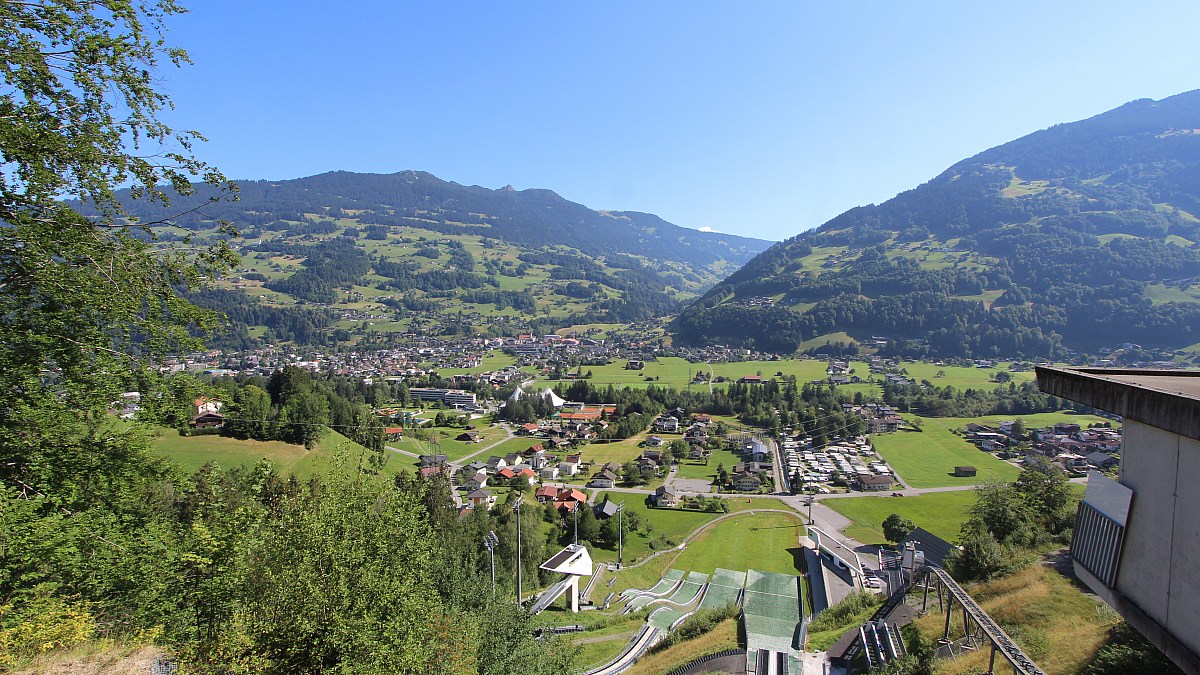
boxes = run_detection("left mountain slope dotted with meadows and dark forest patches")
[84,172,768,347]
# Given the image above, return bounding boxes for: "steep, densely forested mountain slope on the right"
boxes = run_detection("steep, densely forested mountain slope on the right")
[674,91,1200,357]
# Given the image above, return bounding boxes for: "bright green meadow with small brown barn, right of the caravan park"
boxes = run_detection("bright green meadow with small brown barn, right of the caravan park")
[871,418,1021,488]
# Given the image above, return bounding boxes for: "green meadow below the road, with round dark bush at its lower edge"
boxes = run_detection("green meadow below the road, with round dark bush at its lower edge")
[821,490,974,544]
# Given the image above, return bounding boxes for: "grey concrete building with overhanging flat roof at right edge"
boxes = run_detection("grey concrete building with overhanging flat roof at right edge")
[1037,368,1200,675]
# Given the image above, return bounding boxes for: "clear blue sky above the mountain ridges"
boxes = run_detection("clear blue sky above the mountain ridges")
[161,0,1200,239]
